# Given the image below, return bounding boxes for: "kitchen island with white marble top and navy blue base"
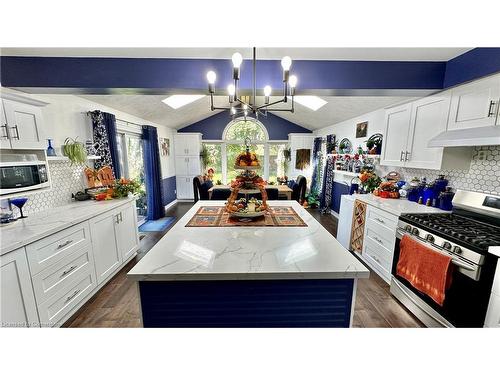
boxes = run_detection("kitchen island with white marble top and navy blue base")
[128,201,369,327]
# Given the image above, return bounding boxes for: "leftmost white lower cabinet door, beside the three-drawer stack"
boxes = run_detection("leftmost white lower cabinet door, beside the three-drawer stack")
[0,248,40,327]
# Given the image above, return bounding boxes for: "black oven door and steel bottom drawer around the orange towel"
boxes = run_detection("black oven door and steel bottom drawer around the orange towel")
[391,230,491,327]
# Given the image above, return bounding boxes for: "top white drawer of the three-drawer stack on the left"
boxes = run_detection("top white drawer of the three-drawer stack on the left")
[26,222,91,275]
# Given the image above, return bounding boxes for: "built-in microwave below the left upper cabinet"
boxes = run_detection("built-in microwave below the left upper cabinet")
[0,160,50,195]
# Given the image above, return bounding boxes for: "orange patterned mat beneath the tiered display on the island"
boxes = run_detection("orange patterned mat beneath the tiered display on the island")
[186,206,307,227]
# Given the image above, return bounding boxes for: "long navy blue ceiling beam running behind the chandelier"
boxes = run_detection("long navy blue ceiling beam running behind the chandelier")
[0,56,446,92]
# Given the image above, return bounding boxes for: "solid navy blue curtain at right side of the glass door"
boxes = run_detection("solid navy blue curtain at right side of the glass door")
[142,125,165,220]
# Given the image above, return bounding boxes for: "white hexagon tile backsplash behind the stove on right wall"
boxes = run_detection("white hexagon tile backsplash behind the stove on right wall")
[377,146,500,195]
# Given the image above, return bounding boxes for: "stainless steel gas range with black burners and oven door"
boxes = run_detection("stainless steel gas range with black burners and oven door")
[390,191,500,327]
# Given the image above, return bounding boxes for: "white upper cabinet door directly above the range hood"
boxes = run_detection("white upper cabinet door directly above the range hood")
[448,75,500,130]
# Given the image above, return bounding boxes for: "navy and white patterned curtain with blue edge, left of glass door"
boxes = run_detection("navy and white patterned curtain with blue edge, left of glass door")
[90,111,122,178]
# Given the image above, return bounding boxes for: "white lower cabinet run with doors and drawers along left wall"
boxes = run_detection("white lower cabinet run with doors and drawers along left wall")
[0,201,139,327]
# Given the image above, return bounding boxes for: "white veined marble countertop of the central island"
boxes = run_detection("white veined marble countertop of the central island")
[128,201,370,281]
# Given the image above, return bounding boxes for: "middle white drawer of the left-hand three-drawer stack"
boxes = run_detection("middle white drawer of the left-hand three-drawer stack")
[33,246,94,305]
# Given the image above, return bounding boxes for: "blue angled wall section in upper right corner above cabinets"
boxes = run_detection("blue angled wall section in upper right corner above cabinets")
[443,48,500,88]
